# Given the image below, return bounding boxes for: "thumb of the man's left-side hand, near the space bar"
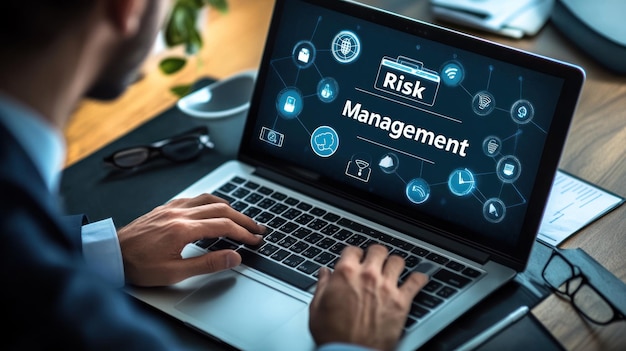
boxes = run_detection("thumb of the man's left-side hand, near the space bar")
[175,250,241,279]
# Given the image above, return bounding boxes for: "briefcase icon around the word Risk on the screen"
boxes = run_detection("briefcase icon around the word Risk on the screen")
[374,56,441,106]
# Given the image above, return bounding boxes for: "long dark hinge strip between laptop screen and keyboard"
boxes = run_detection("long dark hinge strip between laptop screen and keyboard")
[255,166,490,264]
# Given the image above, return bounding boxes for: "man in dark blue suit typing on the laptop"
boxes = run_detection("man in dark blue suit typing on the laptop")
[0,0,427,350]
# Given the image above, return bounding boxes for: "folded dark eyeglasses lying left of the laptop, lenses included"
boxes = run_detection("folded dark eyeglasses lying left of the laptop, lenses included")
[104,126,214,169]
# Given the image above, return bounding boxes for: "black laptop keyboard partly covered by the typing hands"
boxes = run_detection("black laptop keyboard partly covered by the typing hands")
[195,177,482,328]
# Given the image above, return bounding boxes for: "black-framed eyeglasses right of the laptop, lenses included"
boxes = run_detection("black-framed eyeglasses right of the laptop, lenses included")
[541,250,625,325]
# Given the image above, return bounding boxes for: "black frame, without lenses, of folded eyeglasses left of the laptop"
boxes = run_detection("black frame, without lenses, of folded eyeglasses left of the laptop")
[103,126,215,169]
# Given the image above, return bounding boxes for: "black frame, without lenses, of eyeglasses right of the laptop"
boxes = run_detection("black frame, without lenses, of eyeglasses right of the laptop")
[541,249,626,325]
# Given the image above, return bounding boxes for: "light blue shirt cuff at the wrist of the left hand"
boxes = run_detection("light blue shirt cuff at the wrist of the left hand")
[81,218,124,288]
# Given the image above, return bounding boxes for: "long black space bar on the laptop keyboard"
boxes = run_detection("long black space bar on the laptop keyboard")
[238,249,316,290]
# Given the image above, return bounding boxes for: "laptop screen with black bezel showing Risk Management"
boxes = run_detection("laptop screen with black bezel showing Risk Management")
[240,0,583,261]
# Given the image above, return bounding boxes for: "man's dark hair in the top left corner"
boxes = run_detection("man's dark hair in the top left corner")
[0,0,95,51]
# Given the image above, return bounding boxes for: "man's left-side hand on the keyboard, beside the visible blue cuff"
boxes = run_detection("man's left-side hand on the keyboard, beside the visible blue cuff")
[118,194,265,286]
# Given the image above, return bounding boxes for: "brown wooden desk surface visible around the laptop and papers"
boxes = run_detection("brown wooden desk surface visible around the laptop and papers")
[65,0,626,350]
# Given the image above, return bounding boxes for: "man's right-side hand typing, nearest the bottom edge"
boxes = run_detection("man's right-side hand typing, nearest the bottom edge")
[309,245,428,350]
